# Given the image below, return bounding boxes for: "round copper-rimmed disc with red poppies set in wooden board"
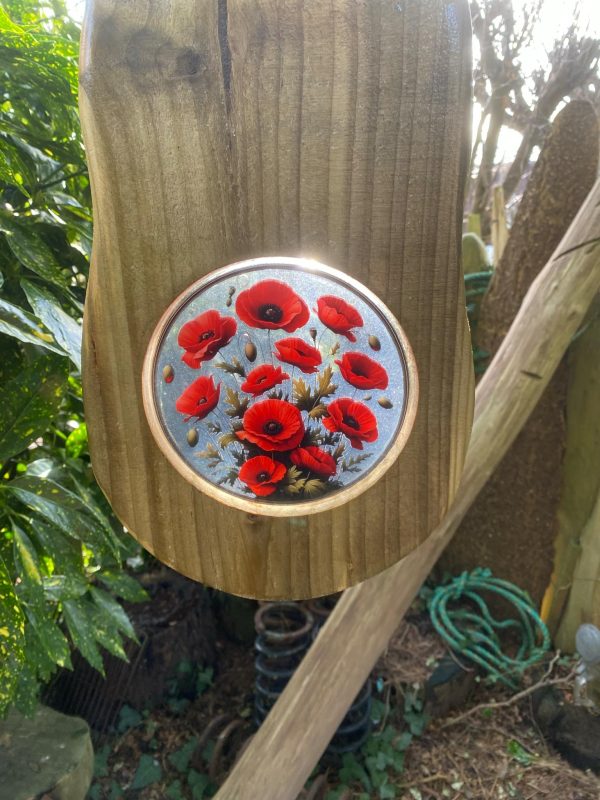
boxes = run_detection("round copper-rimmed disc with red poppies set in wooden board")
[143,258,418,516]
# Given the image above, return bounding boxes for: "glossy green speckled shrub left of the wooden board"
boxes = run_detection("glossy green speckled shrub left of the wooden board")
[0,0,143,714]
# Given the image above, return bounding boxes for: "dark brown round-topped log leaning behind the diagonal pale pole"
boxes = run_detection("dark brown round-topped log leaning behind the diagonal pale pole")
[439,101,599,606]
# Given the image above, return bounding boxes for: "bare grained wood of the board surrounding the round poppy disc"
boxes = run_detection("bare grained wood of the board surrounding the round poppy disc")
[80,0,473,598]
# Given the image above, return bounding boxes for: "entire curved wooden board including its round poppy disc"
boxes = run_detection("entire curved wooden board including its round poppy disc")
[80,0,473,598]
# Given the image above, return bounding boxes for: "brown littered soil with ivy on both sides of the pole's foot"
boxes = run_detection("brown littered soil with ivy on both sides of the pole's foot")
[89,617,600,800]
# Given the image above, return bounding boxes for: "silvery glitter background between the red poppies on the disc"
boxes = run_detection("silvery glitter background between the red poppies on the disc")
[154,264,406,503]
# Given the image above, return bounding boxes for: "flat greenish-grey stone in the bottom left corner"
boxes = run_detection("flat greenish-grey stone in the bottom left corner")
[0,706,94,800]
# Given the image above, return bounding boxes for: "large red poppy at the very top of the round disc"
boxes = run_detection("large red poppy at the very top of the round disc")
[235,280,310,333]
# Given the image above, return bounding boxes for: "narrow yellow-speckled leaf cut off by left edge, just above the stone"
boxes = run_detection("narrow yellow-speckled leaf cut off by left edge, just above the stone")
[0,558,25,717]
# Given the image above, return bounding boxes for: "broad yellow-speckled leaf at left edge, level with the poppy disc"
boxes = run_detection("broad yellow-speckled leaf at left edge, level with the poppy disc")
[0,355,67,461]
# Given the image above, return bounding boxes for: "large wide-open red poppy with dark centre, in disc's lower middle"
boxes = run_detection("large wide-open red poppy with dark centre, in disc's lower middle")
[236,400,304,452]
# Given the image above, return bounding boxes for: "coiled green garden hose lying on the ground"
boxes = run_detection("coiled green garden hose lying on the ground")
[429,567,550,689]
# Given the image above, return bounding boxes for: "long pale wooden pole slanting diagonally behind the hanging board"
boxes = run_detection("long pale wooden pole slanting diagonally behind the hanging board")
[217,181,600,800]
